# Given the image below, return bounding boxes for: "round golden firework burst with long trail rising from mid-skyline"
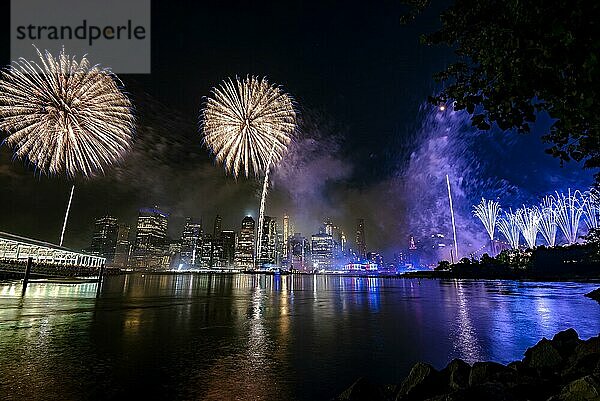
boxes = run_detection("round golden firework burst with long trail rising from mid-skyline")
[201,77,296,266]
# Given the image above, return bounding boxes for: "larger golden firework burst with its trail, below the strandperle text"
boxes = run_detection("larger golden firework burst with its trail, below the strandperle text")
[0,49,134,245]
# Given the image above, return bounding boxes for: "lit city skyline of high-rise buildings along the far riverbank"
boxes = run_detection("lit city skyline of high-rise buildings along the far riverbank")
[84,206,432,272]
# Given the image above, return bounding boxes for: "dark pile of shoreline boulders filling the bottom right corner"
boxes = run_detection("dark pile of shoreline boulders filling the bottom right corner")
[334,329,600,401]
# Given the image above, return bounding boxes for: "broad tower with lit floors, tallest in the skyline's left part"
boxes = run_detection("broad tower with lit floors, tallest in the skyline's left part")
[133,207,169,269]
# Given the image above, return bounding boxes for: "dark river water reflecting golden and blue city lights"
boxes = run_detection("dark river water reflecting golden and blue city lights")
[0,274,600,400]
